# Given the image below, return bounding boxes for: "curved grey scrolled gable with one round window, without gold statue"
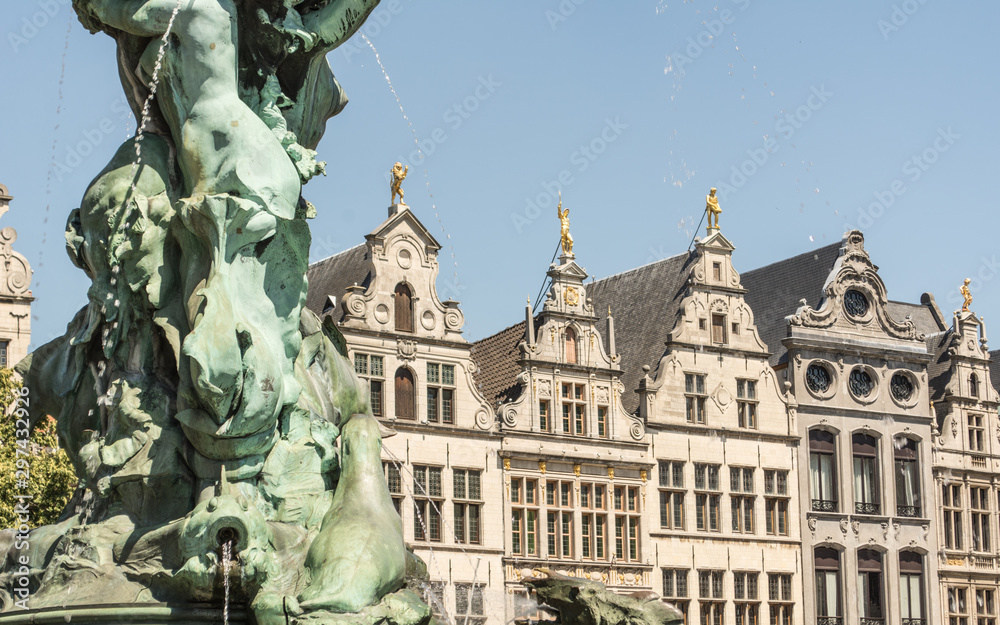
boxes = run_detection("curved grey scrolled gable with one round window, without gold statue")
[788,230,924,341]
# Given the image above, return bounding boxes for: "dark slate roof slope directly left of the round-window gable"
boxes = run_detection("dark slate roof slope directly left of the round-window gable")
[740,241,841,366]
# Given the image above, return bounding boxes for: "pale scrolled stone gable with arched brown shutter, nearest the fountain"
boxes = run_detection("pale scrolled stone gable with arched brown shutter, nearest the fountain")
[342,204,465,343]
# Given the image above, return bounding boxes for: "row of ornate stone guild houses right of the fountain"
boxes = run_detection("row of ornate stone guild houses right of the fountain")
[308,182,1000,625]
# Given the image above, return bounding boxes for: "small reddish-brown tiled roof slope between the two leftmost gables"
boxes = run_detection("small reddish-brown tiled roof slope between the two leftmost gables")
[472,316,540,408]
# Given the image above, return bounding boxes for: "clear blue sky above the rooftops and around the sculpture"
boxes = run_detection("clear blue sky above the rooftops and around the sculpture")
[0,0,1000,346]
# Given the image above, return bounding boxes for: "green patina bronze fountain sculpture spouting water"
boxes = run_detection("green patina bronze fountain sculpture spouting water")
[0,0,430,625]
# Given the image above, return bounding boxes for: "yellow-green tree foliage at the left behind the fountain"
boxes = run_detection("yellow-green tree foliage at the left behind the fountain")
[0,367,78,528]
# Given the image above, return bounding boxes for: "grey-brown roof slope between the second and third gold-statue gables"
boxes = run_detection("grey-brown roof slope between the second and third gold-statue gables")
[584,252,695,413]
